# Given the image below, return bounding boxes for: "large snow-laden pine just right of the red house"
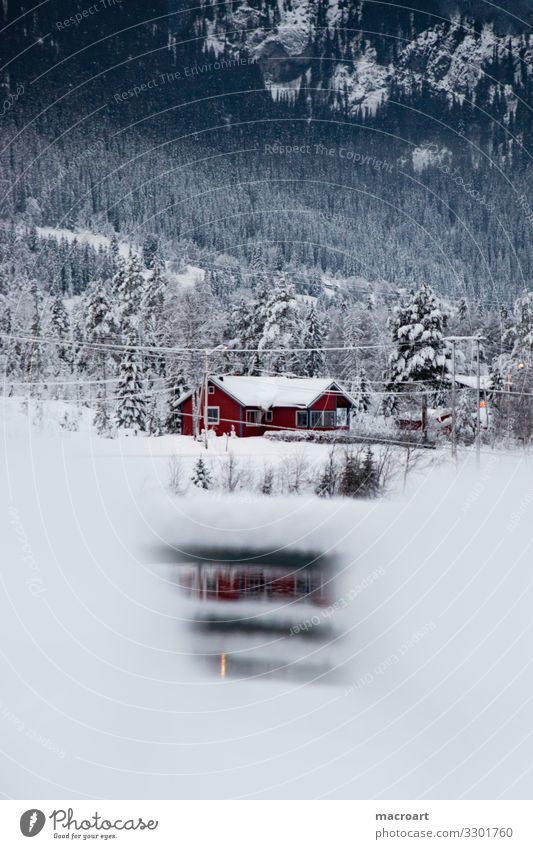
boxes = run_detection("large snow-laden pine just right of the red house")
[389,283,450,386]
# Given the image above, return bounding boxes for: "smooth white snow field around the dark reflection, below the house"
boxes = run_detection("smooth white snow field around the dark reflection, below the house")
[0,400,533,799]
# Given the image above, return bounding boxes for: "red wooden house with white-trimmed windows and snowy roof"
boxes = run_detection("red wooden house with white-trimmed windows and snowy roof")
[178,375,355,436]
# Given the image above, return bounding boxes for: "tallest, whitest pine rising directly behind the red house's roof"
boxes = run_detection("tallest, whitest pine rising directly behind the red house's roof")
[257,272,301,374]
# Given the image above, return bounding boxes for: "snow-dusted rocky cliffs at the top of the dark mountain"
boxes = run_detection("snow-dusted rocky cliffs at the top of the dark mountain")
[200,0,533,115]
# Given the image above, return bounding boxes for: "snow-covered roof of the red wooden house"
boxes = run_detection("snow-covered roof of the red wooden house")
[178,374,355,410]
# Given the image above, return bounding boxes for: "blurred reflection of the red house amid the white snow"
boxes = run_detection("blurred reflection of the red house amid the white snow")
[166,552,338,683]
